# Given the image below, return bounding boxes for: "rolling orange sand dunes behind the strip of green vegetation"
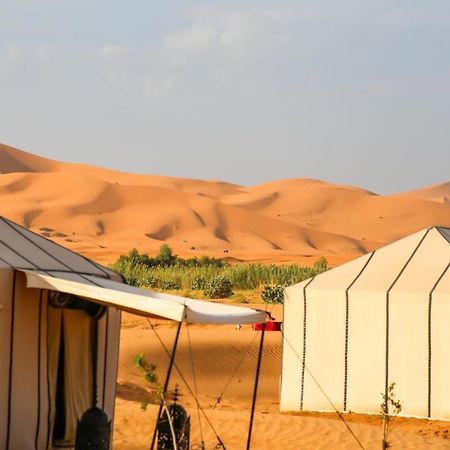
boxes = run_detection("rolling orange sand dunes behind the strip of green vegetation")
[0,145,450,263]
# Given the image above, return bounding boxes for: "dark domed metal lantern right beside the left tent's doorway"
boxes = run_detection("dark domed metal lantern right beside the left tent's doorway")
[75,406,111,450]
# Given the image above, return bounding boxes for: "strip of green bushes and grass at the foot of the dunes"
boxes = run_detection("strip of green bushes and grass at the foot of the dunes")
[111,244,328,303]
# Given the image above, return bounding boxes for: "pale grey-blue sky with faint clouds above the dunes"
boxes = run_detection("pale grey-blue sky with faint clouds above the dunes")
[0,0,450,194]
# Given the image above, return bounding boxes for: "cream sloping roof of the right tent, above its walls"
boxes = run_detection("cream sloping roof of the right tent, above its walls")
[287,226,450,294]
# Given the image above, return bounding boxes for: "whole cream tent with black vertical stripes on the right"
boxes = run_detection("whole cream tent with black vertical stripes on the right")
[281,227,450,419]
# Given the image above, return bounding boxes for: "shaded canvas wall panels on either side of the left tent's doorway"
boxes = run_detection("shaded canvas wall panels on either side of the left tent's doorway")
[0,268,120,450]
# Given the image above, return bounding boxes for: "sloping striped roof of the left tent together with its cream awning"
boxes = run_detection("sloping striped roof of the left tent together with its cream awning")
[0,217,266,324]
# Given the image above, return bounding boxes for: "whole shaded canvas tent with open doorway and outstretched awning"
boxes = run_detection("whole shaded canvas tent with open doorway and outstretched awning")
[0,217,266,450]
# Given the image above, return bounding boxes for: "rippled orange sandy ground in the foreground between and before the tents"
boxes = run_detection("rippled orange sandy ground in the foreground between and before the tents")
[114,307,450,450]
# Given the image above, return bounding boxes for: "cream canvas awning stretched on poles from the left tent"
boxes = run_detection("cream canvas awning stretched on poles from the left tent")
[20,270,267,324]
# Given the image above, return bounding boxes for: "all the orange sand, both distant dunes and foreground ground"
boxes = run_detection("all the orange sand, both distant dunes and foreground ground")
[0,145,450,450]
